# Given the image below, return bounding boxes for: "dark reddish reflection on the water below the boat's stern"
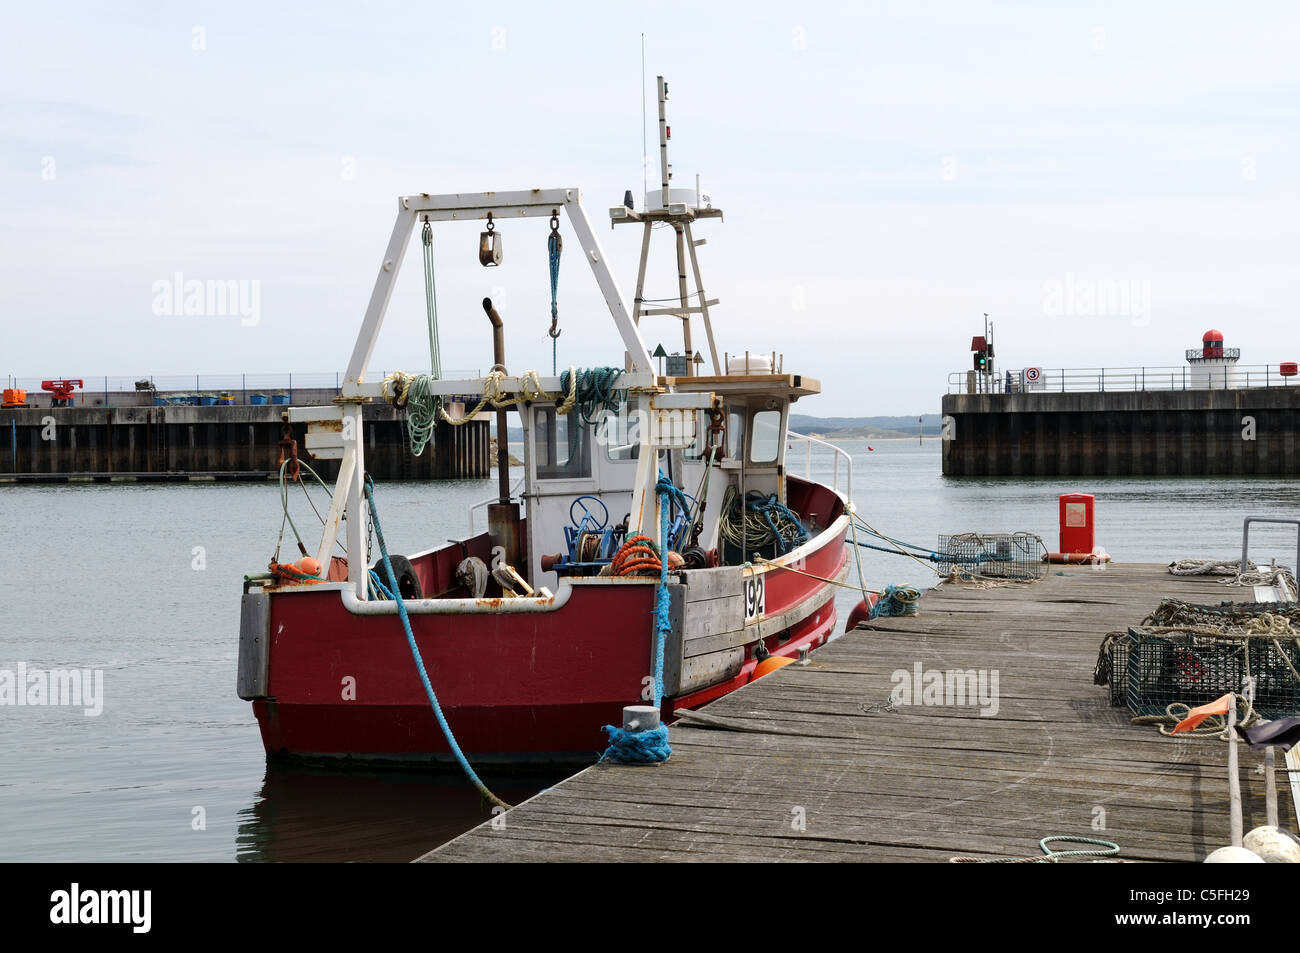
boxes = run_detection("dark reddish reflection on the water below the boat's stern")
[235,761,567,863]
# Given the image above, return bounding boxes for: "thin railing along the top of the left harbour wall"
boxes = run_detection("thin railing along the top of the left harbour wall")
[4,371,481,406]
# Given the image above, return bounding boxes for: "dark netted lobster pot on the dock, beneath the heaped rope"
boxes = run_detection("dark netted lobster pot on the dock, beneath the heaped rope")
[1112,628,1300,719]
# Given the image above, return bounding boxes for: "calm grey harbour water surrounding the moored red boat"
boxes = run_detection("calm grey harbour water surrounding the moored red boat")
[0,441,1300,861]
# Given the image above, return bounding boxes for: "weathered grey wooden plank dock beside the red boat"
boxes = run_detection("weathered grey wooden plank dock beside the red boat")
[419,564,1295,862]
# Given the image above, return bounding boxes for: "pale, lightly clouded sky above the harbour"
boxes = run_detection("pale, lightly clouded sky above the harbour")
[0,0,1300,416]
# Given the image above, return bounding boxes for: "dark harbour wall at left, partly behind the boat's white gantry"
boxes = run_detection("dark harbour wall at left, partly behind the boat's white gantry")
[0,404,490,482]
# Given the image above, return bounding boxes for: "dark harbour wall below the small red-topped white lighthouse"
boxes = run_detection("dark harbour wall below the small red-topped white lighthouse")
[943,387,1300,477]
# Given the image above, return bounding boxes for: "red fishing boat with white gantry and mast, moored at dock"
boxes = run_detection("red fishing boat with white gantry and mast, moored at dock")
[239,78,873,766]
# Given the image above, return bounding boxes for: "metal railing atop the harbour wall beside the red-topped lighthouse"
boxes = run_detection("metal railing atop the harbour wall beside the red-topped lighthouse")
[948,364,1300,394]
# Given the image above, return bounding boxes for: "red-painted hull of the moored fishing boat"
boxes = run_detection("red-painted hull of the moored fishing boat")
[241,478,848,764]
